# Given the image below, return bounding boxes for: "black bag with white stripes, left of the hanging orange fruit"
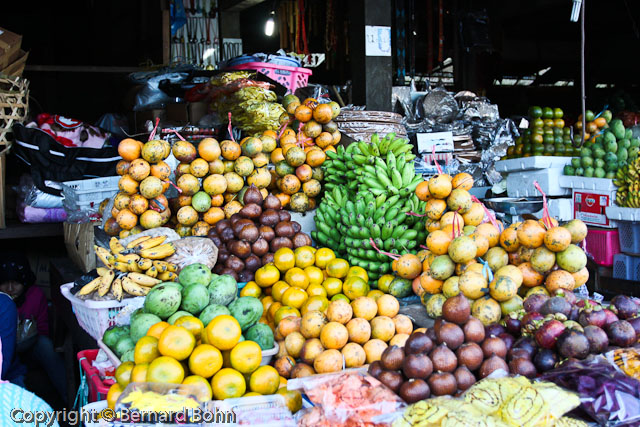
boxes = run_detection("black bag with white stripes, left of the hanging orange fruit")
[13,124,122,196]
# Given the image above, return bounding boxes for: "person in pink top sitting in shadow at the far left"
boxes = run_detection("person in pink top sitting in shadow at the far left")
[0,253,67,402]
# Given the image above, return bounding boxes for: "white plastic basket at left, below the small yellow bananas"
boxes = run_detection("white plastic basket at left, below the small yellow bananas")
[60,283,144,340]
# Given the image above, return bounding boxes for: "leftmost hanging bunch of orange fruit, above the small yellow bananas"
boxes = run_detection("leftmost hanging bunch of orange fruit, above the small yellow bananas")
[105,138,171,238]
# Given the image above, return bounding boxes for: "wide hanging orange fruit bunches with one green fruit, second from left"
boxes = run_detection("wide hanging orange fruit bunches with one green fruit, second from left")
[172,135,276,237]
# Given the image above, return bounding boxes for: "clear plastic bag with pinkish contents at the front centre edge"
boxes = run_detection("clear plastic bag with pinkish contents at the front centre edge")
[289,370,406,427]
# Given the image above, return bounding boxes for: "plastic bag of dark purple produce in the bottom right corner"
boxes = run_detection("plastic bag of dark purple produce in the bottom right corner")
[540,357,640,426]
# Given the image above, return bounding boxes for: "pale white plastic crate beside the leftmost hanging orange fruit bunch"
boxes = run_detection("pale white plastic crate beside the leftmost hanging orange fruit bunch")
[62,176,120,211]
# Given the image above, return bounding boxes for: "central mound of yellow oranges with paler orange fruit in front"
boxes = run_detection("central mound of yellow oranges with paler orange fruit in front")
[255,246,413,378]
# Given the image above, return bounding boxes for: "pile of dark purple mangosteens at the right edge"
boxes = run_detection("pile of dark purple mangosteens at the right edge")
[487,291,640,376]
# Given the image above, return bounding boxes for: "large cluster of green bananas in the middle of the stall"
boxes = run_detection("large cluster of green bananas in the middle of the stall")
[312,134,426,288]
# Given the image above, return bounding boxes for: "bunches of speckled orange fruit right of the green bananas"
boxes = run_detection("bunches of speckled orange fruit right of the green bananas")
[412,173,589,325]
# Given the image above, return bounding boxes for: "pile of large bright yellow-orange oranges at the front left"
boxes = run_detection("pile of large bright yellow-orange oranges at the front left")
[107,314,299,409]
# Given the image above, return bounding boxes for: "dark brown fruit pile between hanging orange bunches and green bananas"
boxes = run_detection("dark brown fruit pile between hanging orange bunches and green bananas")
[209,185,311,282]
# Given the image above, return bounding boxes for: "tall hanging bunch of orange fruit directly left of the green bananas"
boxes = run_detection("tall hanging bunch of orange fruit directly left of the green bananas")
[271,95,340,212]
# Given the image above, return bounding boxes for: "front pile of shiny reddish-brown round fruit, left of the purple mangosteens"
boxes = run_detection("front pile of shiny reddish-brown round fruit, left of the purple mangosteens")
[369,294,509,403]
